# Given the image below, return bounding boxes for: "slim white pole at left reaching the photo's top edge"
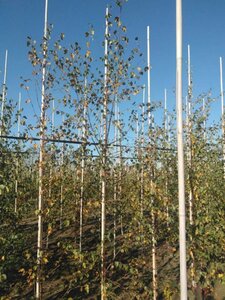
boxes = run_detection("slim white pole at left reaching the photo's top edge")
[36,0,48,299]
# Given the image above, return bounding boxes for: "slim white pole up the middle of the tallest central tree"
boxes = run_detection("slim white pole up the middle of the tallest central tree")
[101,7,109,300]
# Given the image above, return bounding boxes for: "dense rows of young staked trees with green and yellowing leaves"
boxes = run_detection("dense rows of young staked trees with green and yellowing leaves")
[0,2,224,299]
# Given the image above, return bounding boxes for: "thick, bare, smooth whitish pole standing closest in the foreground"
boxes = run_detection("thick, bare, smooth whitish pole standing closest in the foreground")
[176,0,187,300]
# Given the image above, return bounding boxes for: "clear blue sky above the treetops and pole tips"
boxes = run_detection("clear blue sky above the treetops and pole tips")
[0,0,225,134]
